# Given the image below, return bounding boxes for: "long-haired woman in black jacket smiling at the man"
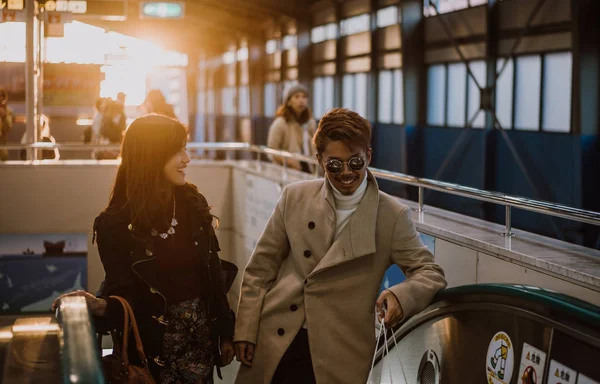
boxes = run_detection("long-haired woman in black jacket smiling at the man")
[54,115,234,383]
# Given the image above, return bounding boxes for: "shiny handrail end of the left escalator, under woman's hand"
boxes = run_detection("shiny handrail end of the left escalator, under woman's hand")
[56,296,104,384]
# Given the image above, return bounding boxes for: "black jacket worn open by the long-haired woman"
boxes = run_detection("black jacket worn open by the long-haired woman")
[94,184,235,377]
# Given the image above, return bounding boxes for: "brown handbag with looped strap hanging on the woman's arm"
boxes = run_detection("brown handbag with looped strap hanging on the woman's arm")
[99,296,156,384]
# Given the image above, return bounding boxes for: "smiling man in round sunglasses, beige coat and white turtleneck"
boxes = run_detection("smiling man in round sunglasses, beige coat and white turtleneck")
[234,108,446,384]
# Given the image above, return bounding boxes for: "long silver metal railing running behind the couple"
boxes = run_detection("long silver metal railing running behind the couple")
[0,143,600,235]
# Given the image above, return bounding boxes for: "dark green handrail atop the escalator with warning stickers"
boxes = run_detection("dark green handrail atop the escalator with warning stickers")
[434,284,600,326]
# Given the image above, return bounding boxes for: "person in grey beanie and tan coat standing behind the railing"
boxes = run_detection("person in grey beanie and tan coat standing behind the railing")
[267,84,316,172]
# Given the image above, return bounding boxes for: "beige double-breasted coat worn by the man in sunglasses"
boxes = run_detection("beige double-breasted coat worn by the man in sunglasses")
[234,172,446,384]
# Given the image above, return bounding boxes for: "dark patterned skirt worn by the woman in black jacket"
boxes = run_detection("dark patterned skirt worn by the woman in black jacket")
[160,298,214,384]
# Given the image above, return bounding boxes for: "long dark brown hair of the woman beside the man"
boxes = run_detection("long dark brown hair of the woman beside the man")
[106,114,187,232]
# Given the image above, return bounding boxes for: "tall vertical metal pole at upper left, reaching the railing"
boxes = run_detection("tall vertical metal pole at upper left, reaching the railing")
[25,0,37,160]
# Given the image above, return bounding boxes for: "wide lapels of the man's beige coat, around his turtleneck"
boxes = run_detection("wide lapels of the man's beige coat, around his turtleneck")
[309,171,379,276]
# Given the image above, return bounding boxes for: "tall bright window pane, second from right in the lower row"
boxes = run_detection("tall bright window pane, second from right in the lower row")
[515,56,542,131]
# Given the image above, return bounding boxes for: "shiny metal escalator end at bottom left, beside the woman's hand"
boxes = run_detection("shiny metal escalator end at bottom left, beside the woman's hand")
[0,297,104,384]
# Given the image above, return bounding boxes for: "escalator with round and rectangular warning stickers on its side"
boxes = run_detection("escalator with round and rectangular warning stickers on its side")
[370,284,600,384]
